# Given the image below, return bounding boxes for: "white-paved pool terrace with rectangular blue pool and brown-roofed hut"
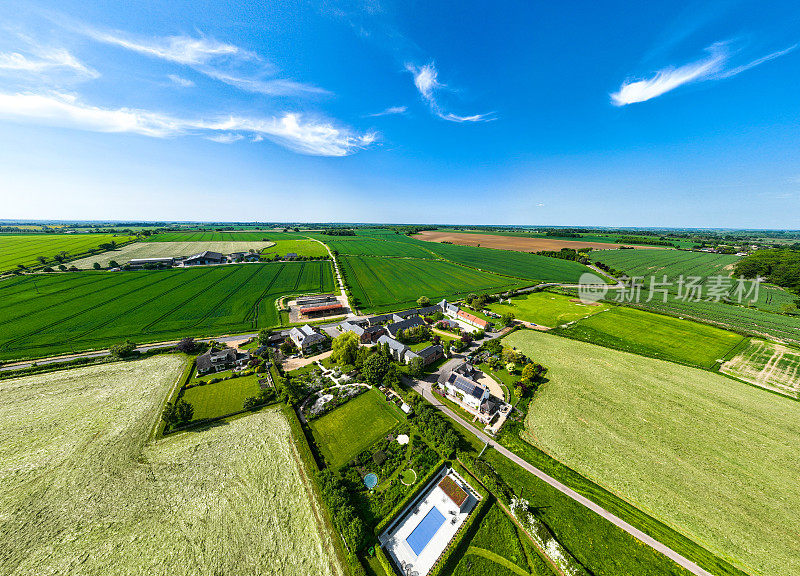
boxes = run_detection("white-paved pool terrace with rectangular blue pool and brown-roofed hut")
[378,468,480,576]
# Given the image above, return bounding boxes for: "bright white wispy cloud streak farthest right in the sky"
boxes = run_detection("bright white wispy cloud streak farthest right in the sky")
[611,42,797,106]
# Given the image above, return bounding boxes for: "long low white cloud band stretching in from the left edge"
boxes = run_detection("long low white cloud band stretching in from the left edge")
[0,93,377,156]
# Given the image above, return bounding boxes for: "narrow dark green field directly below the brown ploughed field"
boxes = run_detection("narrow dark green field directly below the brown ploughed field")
[418,241,588,284]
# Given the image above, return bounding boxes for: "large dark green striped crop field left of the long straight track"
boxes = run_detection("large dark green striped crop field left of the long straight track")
[0,261,334,360]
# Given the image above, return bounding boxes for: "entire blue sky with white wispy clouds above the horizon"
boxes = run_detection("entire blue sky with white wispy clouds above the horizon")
[0,0,800,228]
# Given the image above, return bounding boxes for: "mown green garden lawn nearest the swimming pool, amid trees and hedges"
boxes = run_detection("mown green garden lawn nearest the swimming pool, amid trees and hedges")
[309,389,404,468]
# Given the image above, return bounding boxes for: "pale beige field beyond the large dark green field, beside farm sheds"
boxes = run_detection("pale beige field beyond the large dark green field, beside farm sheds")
[70,242,272,270]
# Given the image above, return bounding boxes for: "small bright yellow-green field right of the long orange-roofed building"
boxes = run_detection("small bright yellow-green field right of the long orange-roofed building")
[488,292,611,328]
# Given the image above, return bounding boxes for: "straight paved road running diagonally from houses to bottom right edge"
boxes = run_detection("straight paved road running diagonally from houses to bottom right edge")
[407,380,713,576]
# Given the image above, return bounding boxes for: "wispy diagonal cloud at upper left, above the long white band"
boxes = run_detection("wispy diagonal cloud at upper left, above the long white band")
[79,26,329,96]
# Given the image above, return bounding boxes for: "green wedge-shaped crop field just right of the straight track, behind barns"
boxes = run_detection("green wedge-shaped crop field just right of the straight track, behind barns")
[339,256,526,312]
